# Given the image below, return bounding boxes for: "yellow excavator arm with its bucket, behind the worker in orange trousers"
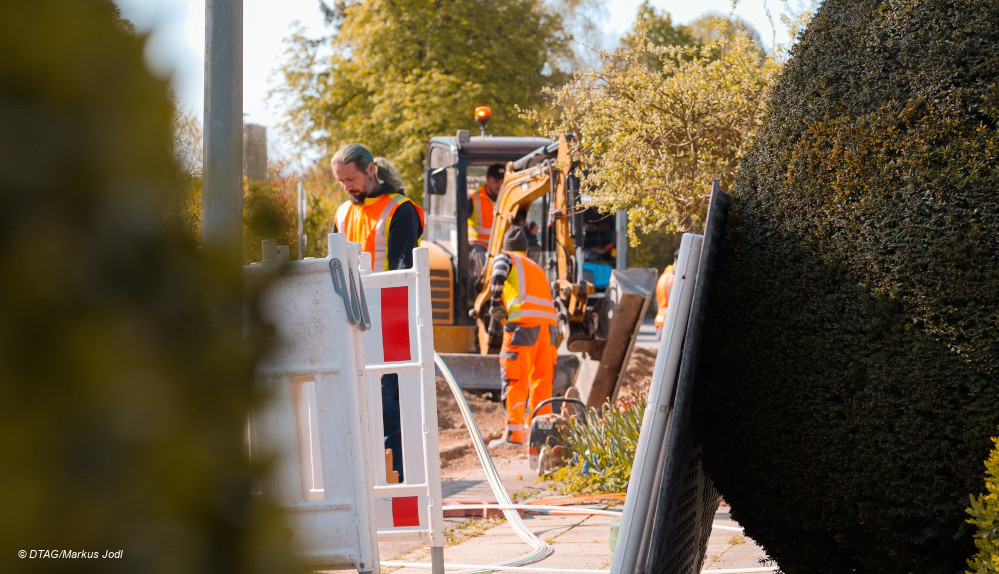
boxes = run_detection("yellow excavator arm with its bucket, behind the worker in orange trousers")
[462,134,658,407]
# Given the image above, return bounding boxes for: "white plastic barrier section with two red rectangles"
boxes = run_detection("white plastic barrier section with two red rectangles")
[361,248,444,572]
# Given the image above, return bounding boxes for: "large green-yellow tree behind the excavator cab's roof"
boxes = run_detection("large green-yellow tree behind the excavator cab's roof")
[278,0,584,205]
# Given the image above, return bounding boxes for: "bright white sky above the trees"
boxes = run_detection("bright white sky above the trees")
[115,0,803,158]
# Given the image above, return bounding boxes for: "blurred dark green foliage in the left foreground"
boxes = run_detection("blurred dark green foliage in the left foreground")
[0,0,297,573]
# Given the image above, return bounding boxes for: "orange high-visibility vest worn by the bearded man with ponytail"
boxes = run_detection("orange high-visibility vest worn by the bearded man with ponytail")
[336,193,414,271]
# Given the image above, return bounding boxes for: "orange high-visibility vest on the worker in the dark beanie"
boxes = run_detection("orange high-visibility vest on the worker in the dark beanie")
[503,251,558,325]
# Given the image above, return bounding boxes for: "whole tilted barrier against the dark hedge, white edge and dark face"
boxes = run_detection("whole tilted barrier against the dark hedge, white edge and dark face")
[611,180,728,574]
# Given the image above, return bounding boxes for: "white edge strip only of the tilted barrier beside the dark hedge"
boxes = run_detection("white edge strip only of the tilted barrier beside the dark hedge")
[611,233,703,574]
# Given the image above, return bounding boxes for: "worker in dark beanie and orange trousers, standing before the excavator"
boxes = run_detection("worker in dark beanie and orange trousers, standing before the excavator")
[489,225,558,447]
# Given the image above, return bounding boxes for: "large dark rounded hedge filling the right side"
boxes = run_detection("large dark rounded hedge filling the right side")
[698,0,999,574]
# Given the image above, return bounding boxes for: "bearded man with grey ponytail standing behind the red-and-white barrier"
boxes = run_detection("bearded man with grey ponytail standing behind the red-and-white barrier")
[330,144,423,481]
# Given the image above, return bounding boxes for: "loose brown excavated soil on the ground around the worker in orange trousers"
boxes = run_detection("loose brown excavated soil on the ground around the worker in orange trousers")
[437,347,656,479]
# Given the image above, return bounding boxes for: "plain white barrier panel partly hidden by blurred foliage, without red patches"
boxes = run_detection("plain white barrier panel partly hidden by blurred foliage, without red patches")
[244,234,382,573]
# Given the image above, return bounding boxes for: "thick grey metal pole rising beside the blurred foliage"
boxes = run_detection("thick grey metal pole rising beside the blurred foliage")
[201,0,243,268]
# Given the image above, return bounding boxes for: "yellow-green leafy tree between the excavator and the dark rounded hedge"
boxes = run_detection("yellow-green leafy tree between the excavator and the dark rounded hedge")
[527,30,778,240]
